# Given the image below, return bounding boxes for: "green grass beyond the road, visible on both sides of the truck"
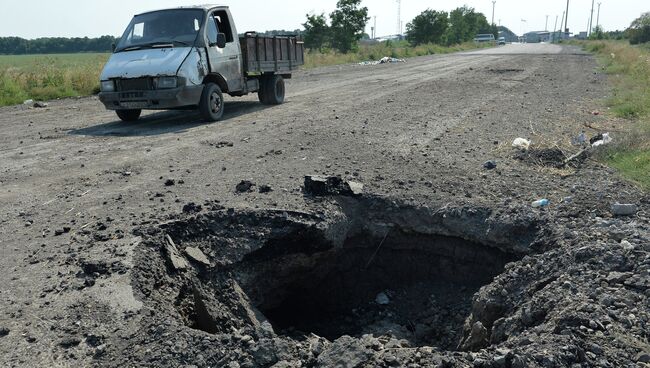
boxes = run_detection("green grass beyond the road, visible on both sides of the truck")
[0,42,486,106]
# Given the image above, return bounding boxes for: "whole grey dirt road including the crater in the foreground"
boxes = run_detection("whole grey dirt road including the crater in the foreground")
[0,45,650,368]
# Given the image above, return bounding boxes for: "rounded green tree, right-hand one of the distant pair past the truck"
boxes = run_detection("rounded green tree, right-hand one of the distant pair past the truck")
[447,6,488,45]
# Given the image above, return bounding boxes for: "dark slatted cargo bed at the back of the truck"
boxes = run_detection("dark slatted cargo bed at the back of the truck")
[239,32,305,75]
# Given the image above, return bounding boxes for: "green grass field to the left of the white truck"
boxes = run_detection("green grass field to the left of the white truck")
[0,54,109,106]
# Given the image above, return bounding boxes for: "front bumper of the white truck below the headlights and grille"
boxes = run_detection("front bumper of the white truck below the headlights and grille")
[99,85,203,110]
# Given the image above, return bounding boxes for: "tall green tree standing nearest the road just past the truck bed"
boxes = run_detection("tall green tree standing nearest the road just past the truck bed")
[330,0,370,53]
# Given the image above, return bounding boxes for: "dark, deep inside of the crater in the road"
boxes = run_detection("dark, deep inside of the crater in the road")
[235,229,515,350]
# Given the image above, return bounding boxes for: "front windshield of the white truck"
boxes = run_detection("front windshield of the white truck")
[115,9,204,52]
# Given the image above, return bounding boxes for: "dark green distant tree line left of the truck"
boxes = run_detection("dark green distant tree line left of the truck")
[0,36,119,55]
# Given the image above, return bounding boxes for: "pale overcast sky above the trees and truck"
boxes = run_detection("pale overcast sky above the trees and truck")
[0,0,650,38]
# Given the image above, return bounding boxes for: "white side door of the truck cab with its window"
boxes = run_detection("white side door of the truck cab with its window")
[207,10,244,92]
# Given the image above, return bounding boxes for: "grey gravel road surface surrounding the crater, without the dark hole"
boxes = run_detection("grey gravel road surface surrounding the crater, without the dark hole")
[0,44,650,367]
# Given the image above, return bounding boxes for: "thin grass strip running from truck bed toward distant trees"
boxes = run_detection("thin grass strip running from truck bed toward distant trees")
[305,41,491,69]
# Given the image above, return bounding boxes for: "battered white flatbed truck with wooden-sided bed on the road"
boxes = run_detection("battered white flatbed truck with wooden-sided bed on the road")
[99,5,304,122]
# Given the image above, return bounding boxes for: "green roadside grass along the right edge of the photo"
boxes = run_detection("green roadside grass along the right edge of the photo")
[584,41,650,191]
